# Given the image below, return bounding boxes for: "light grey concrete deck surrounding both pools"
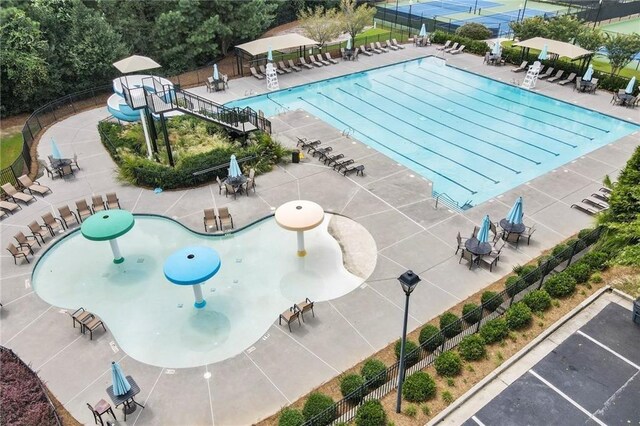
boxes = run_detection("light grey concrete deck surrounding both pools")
[0,46,640,425]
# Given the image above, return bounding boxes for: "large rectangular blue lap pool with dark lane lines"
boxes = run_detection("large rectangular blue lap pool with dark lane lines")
[227,57,640,207]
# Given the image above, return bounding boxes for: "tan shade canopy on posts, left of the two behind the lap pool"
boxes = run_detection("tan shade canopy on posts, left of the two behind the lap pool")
[235,34,319,75]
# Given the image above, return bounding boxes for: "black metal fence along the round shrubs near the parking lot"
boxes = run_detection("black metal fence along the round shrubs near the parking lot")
[304,228,602,426]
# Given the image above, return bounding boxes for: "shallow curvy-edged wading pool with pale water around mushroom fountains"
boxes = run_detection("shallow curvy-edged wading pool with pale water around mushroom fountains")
[32,214,364,368]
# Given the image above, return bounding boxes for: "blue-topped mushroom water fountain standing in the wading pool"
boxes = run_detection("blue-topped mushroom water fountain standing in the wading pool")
[164,246,221,309]
